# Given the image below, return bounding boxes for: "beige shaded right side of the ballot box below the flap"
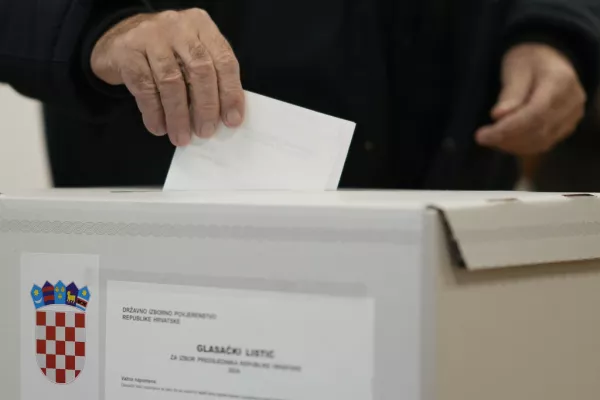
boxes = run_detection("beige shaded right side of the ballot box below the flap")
[427,213,600,400]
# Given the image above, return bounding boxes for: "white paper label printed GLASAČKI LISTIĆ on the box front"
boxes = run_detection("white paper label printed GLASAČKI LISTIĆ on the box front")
[105,281,374,400]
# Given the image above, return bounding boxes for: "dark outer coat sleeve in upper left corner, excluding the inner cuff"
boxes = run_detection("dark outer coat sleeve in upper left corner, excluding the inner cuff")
[0,0,98,117]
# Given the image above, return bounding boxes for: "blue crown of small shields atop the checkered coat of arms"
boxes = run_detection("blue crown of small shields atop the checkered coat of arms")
[31,281,90,312]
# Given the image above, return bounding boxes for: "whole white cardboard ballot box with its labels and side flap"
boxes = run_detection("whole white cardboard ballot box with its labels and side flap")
[0,190,600,400]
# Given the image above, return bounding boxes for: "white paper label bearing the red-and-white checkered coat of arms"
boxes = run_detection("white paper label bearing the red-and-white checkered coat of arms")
[20,254,100,400]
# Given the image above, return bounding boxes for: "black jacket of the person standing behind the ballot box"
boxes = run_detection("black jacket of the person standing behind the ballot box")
[0,0,600,190]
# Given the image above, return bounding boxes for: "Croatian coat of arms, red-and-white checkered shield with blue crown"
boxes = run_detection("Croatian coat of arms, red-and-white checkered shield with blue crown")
[31,281,90,384]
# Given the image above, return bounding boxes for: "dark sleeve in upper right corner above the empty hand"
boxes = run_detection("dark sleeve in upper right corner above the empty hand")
[505,0,600,98]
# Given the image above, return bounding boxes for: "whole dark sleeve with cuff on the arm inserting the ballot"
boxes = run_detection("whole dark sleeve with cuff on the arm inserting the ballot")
[0,0,146,121]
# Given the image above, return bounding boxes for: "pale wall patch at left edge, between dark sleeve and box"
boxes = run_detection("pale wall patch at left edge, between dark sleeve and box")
[0,85,50,193]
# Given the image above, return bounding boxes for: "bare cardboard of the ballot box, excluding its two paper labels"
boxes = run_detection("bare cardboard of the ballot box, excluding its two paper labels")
[0,190,600,400]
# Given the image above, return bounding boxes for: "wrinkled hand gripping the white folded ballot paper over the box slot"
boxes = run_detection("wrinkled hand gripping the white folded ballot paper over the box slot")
[91,9,244,146]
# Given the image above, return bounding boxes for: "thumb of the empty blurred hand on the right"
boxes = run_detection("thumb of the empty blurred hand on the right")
[492,62,534,120]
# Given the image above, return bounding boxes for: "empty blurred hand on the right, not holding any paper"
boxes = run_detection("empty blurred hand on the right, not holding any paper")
[476,44,586,156]
